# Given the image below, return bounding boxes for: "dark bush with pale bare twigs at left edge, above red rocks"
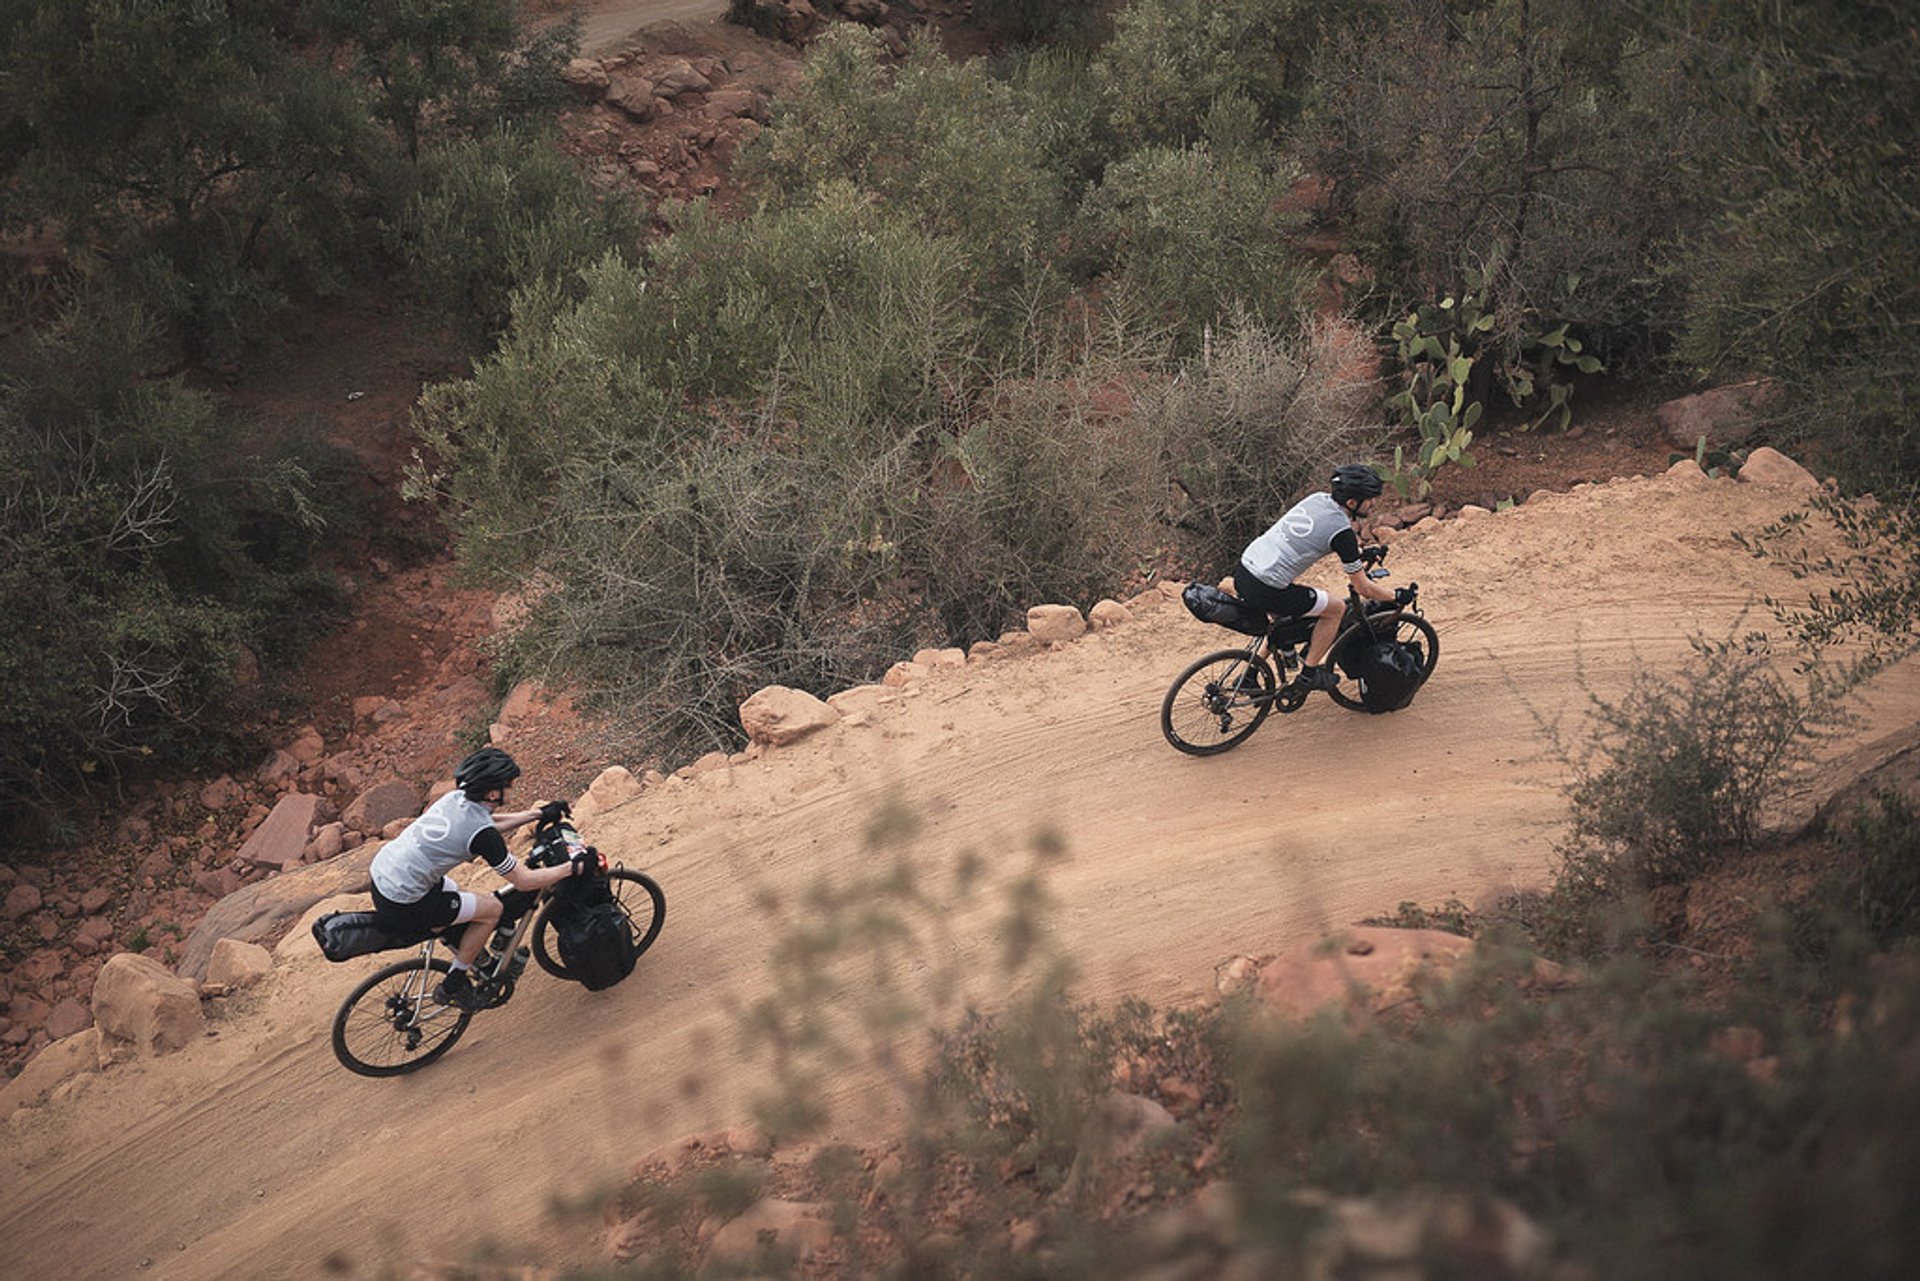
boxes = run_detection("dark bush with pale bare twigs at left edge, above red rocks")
[0,313,336,833]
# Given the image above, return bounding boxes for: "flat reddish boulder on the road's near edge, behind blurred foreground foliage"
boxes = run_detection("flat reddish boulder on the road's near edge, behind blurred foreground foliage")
[1256,926,1473,1020]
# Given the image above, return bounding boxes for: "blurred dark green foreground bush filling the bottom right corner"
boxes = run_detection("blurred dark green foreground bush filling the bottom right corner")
[1229,937,1920,1279]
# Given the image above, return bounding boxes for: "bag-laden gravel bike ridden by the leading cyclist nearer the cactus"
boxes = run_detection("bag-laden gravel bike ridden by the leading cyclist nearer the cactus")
[1160,544,1440,757]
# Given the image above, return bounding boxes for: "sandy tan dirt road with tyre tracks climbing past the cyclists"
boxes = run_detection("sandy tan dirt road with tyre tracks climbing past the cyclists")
[0,462,1920,1277]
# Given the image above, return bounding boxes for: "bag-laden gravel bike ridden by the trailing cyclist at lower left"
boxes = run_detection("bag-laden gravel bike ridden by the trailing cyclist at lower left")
[334,837,666,1076]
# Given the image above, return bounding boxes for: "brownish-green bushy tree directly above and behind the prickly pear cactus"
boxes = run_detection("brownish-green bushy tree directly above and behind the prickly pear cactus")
[1292,0,1704,391]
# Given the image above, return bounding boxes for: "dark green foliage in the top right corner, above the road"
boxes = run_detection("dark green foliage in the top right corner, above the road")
[1668,4,1920,499]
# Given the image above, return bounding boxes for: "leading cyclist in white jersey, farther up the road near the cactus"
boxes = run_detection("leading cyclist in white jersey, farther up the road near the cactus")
[1233,463,1411,689]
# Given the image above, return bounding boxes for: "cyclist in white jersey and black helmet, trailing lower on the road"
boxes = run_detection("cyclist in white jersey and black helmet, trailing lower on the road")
[369,747,601,1010]
